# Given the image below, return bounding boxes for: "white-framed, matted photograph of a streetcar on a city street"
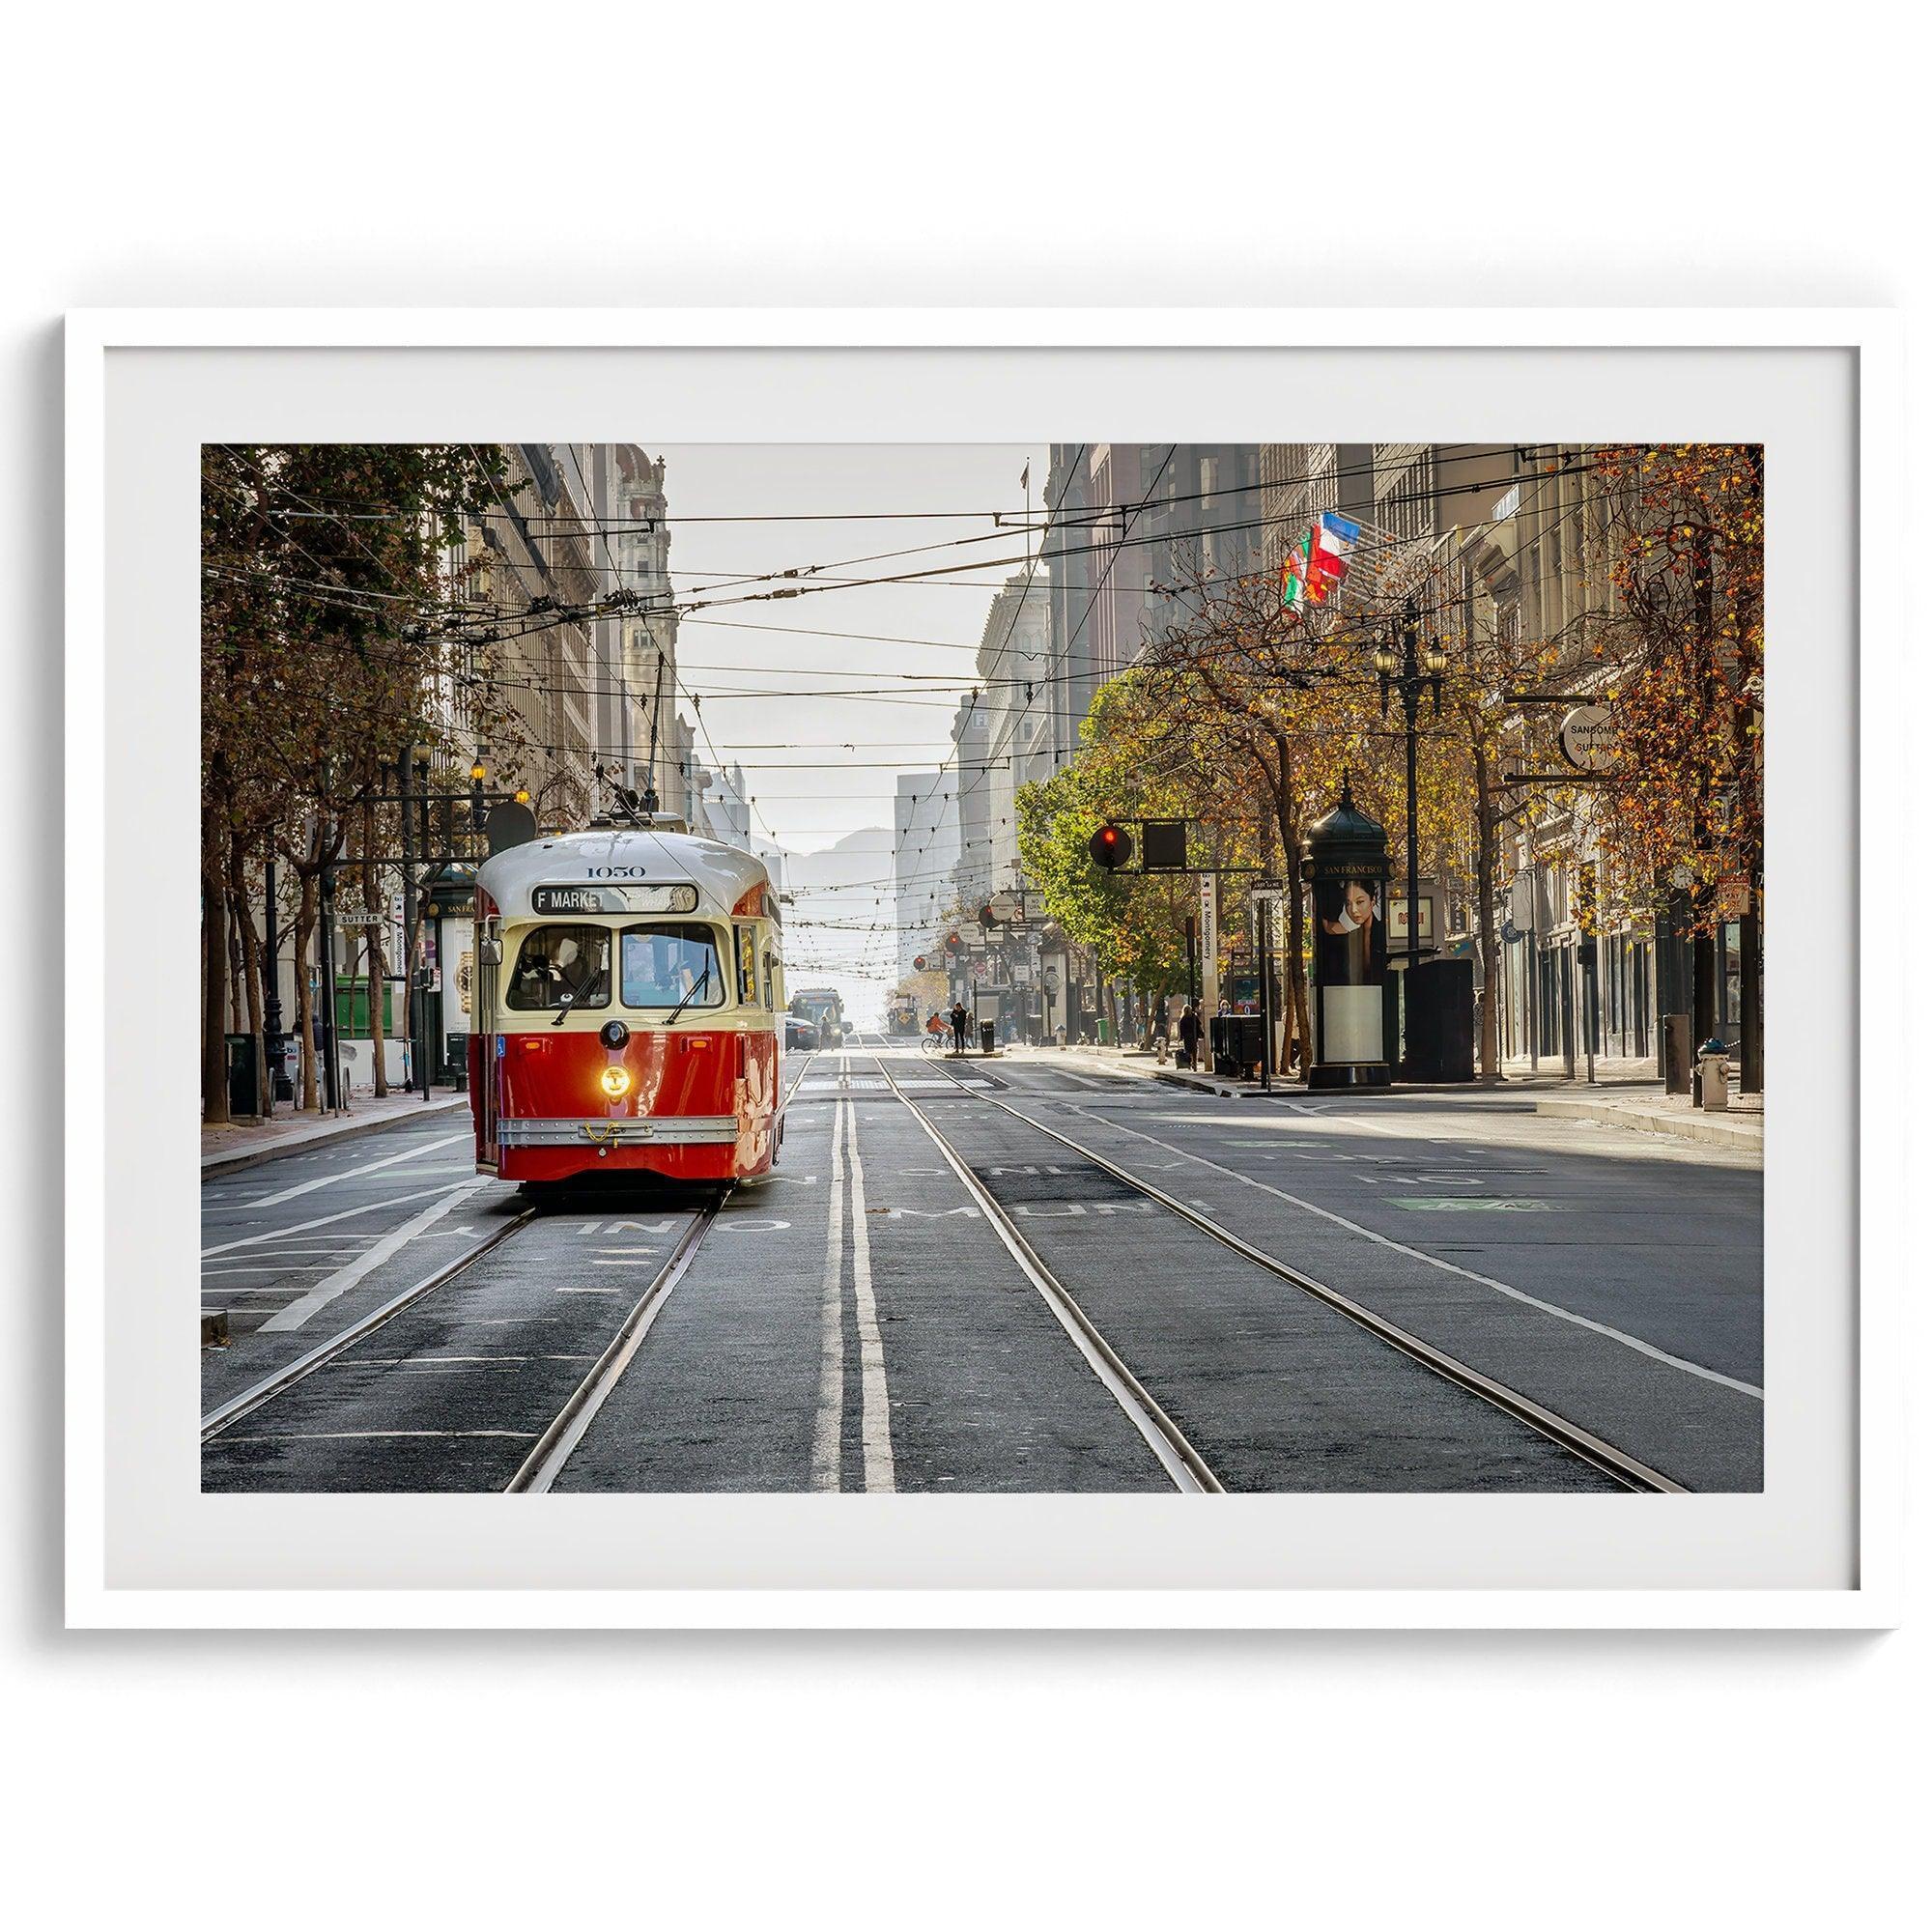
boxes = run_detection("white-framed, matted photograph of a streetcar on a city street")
[62,309,1905,1629]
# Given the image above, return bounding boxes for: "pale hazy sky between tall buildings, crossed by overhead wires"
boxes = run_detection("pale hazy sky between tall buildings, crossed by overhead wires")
[651,442,1047,1014]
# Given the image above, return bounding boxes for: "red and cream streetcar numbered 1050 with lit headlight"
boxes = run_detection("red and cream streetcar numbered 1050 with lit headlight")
[469,825,784,1182]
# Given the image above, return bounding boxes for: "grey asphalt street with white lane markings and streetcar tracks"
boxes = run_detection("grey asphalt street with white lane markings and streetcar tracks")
[203,1036,1762,1493]
